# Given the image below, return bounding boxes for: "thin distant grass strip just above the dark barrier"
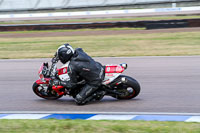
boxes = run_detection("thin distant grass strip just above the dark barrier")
[0,15,200,24]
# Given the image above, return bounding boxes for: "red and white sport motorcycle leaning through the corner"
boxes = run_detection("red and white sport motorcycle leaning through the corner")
[32,57,140,102]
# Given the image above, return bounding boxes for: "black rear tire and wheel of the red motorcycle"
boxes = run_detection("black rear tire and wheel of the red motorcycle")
[114,75,140,100]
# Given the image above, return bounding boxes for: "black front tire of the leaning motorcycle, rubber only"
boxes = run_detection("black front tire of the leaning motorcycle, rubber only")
[32,82,63,100]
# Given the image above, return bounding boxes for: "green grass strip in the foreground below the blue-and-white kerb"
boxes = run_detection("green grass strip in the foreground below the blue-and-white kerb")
[0,119,200,133]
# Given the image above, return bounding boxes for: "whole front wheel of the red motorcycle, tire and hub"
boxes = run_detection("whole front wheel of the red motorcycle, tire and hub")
[32,82,63,100]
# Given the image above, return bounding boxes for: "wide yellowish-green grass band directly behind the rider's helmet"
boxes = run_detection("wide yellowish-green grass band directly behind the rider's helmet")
[0,32,200,59]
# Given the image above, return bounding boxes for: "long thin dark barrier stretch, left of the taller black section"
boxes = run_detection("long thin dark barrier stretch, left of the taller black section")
[0,22,144,31]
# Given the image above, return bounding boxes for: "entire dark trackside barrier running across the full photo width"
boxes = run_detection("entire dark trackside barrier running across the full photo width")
[0,19,200,31]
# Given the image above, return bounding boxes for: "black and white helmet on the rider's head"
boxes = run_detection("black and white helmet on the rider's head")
[57,44,74,64]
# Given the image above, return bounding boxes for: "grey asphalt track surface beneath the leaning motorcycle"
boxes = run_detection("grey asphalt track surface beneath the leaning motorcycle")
[0,56,200,113]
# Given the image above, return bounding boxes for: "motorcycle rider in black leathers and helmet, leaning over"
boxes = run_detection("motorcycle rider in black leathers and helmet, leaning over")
[50,44,104,105]
